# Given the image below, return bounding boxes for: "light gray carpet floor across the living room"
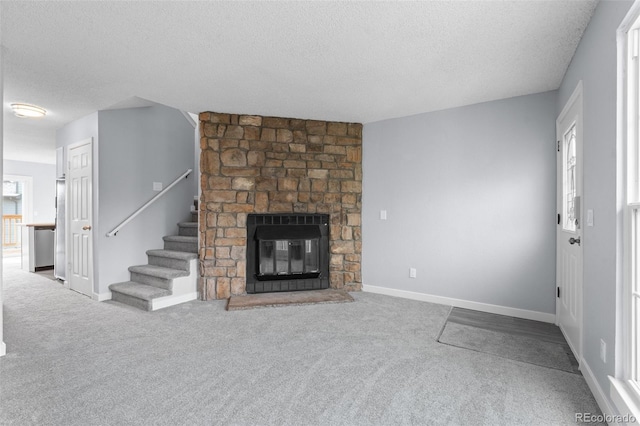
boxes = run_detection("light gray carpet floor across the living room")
[0,255,599,426]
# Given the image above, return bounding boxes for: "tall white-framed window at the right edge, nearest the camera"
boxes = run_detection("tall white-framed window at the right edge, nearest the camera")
[610,1,640,419]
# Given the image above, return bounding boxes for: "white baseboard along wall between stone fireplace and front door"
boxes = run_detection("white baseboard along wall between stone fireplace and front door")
[362,285,556,323]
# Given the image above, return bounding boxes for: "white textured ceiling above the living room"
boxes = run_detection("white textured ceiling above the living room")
[0,0,597,162]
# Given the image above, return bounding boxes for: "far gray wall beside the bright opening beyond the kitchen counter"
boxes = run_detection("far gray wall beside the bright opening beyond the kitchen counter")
[4,160,56,223]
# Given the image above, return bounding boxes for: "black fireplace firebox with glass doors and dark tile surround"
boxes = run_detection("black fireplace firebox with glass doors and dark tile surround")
[246,213,329,293]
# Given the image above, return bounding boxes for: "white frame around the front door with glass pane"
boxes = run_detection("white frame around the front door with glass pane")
[556,80,586,367]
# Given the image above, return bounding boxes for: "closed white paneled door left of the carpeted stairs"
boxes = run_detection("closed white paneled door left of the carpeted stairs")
[67,139,93,296]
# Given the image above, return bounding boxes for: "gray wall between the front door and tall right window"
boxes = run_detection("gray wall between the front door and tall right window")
[556,1,632,402]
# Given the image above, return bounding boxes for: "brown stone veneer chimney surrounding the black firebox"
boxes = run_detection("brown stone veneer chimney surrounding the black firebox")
[199,112,362,300]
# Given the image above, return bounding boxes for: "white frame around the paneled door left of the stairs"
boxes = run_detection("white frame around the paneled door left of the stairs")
[64,138,96,299]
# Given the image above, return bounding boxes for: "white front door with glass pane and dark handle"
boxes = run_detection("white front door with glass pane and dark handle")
[556,83,584,362]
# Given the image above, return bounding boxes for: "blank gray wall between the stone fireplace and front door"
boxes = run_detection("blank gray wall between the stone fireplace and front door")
[362,92,557,313]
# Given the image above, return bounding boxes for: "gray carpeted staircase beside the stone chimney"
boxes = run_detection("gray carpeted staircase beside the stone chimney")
[109,218,198,311]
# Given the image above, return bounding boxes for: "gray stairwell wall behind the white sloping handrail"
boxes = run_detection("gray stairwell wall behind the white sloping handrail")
[96,106,198,293]
